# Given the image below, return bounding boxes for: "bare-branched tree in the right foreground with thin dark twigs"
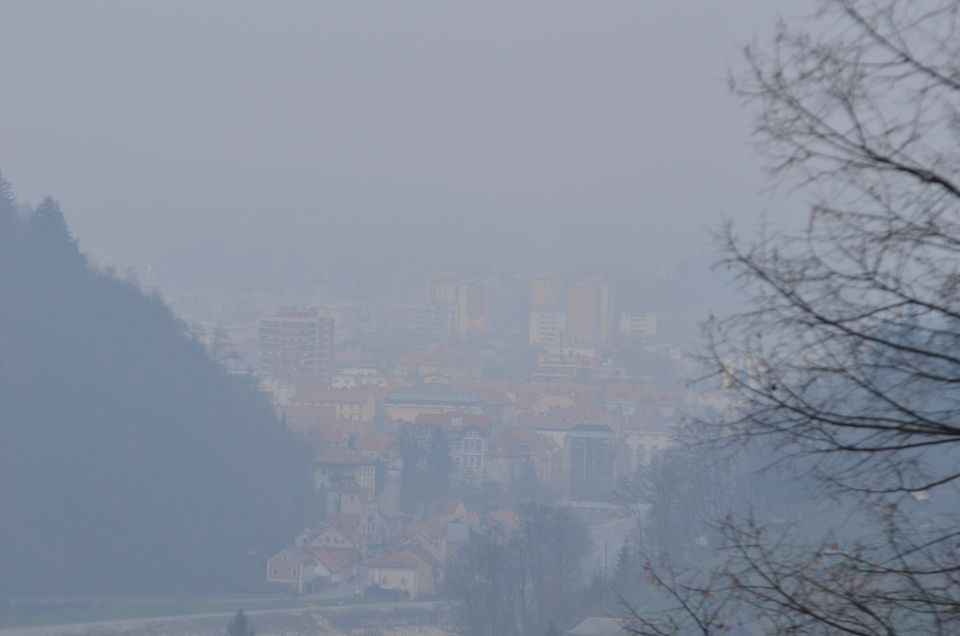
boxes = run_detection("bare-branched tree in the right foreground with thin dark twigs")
[635,0,960,636]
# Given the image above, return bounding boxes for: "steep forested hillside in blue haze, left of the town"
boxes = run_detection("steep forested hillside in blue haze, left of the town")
[0,178,308,601]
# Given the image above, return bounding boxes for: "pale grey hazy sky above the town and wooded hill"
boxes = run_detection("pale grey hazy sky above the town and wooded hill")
[0,0,802,286]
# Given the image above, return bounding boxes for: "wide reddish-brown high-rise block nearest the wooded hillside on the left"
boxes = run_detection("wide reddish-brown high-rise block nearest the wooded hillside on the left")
[259,307,334,383]
